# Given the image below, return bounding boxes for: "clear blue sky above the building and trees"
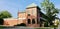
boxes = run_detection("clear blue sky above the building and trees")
[0,0,60,18]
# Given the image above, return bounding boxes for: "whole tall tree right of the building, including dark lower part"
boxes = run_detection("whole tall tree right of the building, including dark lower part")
[41,0,59,24]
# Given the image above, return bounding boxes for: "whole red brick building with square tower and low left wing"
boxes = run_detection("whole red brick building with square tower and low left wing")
[4,3,44,27]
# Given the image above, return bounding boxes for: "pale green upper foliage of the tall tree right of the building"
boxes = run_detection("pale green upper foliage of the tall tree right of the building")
[41,0,58,16]
